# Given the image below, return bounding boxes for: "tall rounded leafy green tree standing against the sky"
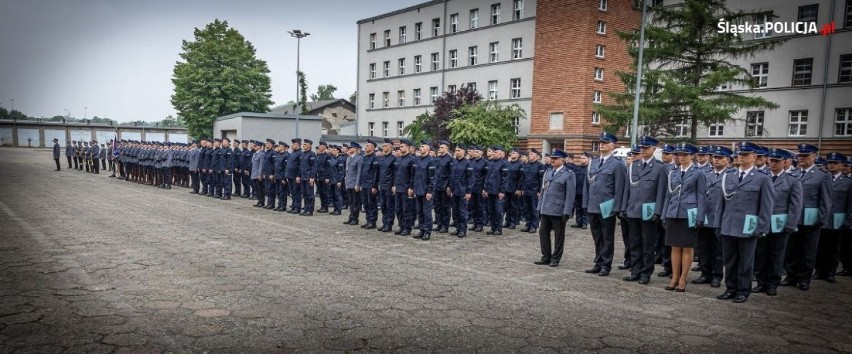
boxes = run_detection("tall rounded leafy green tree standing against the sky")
[172,19,273,138]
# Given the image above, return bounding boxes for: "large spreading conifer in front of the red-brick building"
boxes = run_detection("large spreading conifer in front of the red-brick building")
[596,0,782,141]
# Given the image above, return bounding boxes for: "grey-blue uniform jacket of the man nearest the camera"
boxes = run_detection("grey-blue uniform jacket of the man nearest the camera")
[715,169,775,237]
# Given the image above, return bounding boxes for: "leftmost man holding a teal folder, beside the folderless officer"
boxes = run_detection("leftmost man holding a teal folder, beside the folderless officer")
[583,133,627,276]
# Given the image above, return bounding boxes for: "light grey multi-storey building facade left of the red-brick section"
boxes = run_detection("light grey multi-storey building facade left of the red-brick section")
[356,0,537,138]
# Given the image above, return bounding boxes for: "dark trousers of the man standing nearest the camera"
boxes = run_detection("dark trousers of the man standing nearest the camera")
[722,235,757,294]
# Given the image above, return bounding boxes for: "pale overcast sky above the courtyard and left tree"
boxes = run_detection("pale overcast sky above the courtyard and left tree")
[0,0,425,122]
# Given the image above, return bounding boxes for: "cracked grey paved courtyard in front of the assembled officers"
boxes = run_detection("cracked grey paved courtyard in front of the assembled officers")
[0,148,852,353]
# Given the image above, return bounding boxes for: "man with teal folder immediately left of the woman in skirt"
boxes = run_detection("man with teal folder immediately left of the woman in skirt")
[621,136,668,284]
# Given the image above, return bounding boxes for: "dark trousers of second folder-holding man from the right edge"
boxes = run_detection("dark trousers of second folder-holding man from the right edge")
[784,225,820,284]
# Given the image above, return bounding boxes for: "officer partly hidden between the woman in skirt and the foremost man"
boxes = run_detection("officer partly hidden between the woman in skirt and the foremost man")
[692,146,733,288]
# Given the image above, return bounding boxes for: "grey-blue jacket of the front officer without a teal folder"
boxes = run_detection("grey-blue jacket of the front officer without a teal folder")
[537,166,577,216]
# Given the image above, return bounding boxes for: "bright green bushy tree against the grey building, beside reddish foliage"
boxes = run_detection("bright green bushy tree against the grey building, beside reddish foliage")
[446,101,527,148]
